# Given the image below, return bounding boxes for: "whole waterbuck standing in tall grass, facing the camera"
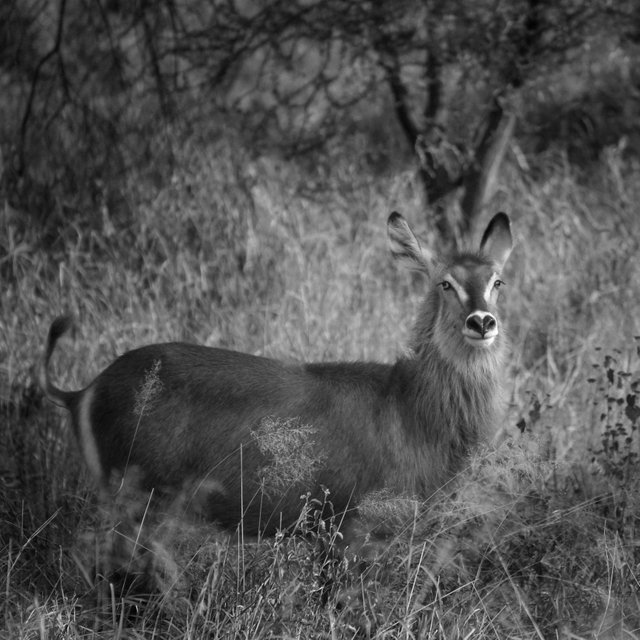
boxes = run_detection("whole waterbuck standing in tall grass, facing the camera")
[40,212,512,533]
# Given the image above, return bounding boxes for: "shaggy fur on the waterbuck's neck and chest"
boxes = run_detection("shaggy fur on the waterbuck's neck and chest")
[388,282,505,495]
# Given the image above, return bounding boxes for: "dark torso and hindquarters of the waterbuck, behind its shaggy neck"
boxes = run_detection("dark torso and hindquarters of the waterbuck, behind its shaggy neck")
[41,336,395,533]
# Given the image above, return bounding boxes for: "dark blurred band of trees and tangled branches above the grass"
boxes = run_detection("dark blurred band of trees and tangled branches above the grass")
[0,0,640,240]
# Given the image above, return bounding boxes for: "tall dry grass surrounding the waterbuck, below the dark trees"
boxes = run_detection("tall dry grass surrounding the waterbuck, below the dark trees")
[0,125,640,639]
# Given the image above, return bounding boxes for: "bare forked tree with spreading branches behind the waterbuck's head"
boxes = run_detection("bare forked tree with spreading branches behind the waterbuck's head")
[161,0,630,241]
